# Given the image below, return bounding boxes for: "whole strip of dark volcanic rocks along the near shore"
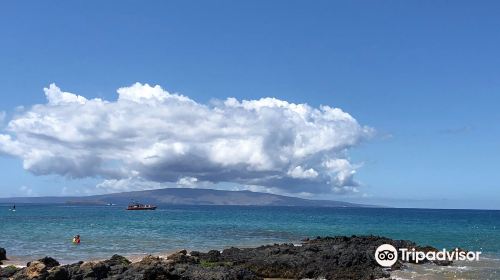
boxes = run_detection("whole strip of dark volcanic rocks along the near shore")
[0,236,451,280]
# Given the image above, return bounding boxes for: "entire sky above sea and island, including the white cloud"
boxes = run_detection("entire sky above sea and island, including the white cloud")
[0,0,500,209]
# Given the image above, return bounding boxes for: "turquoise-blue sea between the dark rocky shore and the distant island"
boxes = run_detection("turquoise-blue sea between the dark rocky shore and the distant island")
[0,205,500,262]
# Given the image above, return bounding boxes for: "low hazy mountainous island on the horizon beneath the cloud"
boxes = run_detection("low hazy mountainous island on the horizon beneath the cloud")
[0,188,371,207]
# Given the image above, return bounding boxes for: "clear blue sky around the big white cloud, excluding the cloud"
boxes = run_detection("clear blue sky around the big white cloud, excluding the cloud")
[0,1,500,209]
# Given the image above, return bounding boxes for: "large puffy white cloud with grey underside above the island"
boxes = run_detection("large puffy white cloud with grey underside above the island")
[0,83,373,193]
